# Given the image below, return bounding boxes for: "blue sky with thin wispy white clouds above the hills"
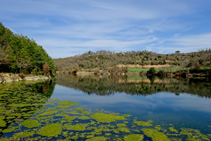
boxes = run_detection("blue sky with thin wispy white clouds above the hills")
[0,0,211,58]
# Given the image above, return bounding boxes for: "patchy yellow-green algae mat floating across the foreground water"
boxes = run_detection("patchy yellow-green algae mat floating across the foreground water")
[0,82,211,141]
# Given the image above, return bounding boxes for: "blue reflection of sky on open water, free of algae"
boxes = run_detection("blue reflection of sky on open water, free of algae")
[51,85,211,132]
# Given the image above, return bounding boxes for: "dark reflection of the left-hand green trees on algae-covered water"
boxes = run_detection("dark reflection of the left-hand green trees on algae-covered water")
[0,81,55,135]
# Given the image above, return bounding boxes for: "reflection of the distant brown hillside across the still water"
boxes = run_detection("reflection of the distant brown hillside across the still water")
[56,75,211,98]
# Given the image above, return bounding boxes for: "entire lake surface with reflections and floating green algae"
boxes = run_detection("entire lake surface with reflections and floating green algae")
[0,75,211,141]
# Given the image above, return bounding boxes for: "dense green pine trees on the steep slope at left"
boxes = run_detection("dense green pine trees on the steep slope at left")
[0,23,55,74]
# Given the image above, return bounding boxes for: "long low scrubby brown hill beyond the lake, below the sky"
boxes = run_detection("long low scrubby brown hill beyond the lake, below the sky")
[54,49,211,71]
